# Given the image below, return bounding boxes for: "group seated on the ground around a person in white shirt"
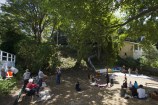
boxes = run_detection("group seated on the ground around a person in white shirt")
[121,74,147,99]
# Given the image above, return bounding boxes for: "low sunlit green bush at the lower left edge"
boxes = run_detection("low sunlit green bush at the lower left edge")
[0,78,16,95]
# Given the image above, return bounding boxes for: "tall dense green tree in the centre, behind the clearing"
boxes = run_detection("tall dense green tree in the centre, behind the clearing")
[57,0,118,66]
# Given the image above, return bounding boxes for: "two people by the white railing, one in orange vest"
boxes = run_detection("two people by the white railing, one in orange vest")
[1,66,14,79]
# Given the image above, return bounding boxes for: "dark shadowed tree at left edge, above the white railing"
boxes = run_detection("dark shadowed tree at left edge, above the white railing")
[0,13,25,54]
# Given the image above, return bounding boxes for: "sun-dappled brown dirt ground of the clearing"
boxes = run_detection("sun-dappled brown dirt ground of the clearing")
[3,70,158,105]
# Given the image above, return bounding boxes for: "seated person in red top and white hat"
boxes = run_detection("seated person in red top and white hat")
[25,79,39,95]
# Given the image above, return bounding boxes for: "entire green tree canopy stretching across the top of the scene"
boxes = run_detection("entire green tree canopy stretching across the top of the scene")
[1,0,158,69]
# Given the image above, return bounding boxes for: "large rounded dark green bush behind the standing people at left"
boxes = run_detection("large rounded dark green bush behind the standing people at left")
[17,38,58,72]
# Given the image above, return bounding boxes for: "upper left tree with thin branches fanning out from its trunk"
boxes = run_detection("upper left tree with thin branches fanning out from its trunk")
[2,0,60,43]
